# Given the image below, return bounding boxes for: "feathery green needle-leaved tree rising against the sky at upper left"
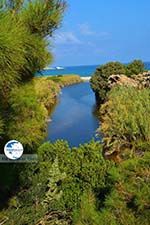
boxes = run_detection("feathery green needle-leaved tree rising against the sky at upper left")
[0,0,65,142]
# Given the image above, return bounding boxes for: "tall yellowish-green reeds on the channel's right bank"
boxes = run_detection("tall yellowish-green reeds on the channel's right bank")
[101,86,150,156]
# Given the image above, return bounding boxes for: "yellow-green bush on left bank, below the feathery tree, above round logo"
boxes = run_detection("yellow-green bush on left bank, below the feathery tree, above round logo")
[6,84,48,148]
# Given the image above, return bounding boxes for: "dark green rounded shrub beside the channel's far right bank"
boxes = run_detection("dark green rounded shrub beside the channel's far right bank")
[91,62,126,103]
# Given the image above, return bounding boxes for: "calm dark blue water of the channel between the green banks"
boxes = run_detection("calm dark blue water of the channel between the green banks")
[47,82,99,146]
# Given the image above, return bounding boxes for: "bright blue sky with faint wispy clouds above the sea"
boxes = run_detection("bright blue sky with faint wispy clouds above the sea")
[52,0,150,66]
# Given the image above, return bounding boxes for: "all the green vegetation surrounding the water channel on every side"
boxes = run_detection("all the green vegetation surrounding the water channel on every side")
[0,0,150,225]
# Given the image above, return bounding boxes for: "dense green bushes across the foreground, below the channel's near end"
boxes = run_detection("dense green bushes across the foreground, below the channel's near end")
[0,141,150,225]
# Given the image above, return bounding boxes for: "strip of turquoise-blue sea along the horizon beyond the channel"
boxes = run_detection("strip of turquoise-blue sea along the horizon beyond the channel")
[36,62,150,77]
